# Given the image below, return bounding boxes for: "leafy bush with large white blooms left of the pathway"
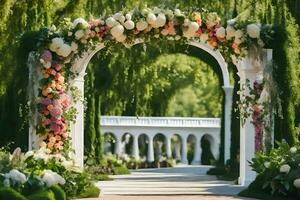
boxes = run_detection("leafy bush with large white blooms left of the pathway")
[0,147,98,199]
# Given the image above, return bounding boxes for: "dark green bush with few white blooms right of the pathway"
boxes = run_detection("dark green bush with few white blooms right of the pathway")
[250,142,300,196]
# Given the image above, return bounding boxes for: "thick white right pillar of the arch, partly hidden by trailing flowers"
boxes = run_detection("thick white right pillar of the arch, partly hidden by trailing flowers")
[238,50,272,186]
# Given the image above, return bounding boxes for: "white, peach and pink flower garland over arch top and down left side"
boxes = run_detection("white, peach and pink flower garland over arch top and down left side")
[32,7,270,153]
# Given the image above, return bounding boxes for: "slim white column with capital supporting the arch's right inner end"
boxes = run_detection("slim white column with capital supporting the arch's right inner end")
[223,86,233,163]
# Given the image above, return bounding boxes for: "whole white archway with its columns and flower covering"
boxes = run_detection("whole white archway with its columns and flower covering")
[28,7,272,185]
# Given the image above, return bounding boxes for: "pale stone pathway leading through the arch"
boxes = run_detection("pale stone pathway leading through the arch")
[93,166,253,200]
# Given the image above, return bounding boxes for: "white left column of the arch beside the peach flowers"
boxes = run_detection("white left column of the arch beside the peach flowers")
[71,76,84,167]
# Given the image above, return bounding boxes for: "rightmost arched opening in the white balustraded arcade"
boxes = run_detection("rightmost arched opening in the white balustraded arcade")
[201,134,217,165]
